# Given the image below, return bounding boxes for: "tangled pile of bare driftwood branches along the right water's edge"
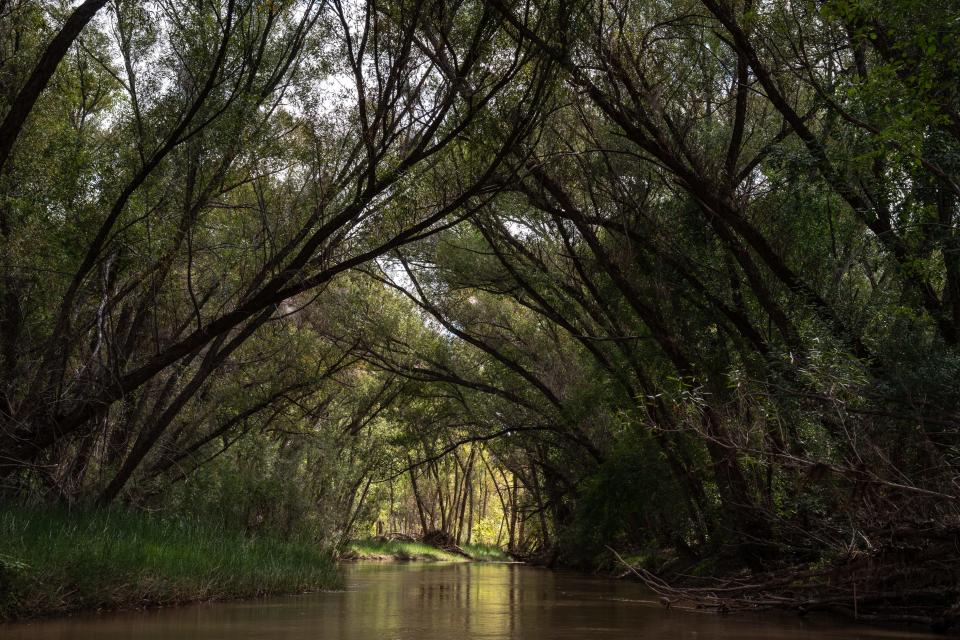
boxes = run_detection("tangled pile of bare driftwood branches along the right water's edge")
[607,529,960,632]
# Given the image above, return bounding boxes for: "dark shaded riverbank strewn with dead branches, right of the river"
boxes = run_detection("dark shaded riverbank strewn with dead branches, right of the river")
[607,539,960,635]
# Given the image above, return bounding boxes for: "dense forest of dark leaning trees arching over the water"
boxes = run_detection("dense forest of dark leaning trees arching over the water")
[0,0,960,630]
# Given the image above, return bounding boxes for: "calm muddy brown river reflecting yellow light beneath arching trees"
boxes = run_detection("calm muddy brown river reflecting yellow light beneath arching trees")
[0,563,941,640]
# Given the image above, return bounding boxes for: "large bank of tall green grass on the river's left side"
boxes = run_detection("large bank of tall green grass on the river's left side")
[0,507,341,620]
